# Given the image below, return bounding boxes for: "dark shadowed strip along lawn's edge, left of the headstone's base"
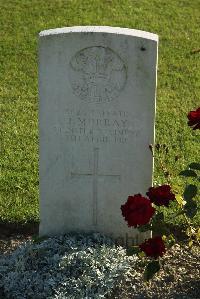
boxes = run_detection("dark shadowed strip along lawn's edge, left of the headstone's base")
[0,219,39,237]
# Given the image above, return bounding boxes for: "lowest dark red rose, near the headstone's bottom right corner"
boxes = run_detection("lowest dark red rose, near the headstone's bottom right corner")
[139,236,166,258]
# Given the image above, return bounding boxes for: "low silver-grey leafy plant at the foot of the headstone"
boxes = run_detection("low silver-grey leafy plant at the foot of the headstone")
[0,233,137,299]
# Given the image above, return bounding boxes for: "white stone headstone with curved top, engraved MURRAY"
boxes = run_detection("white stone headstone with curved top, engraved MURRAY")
[39,26,158,243]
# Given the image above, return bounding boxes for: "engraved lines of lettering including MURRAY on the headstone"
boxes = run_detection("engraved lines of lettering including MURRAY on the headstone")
[55,108,141,144]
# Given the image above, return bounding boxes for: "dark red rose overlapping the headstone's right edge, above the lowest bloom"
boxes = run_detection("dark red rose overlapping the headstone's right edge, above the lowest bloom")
[146,185,175,207]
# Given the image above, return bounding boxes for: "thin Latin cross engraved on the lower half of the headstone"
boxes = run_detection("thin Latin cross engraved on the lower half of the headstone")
[71,148,120,226]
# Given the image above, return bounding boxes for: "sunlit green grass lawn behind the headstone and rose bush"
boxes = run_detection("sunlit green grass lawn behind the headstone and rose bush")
[0,0,200,229]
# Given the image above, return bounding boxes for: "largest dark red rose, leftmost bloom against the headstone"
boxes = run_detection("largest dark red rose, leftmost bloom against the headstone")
[121,194,155,227]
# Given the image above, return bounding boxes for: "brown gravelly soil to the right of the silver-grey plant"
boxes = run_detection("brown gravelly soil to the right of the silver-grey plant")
[110,244,200,299]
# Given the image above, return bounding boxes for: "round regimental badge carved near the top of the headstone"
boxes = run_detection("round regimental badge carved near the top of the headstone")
[70,46,126,103]
